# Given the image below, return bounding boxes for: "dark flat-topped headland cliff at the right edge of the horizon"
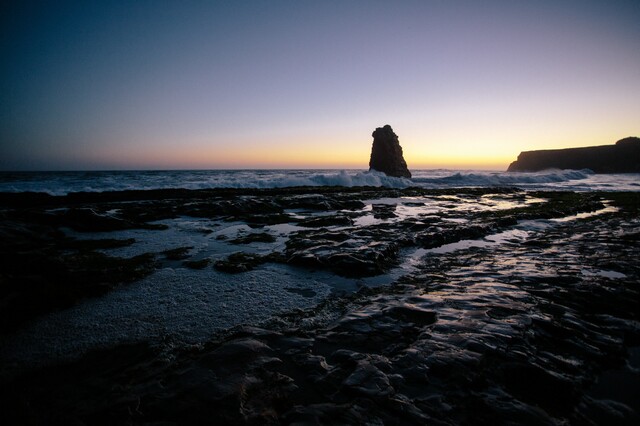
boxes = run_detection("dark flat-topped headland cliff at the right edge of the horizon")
[507,137,640,173]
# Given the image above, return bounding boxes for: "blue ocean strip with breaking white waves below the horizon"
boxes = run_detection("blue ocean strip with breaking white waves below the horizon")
[0,169,640,195]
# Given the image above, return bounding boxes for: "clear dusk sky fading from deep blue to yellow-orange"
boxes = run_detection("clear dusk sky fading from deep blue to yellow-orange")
[0,0,640,170]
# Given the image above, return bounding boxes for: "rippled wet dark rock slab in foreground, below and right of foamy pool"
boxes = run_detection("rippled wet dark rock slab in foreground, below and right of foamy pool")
[0,194,640,425]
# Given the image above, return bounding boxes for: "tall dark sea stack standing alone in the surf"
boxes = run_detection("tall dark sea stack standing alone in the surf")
[369,124,411,178]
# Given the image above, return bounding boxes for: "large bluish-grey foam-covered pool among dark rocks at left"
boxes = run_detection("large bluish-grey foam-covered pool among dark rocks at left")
[0,265,330,368]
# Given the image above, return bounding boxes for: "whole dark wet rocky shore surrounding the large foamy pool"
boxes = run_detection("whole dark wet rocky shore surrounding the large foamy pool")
[0,187,640,424]
